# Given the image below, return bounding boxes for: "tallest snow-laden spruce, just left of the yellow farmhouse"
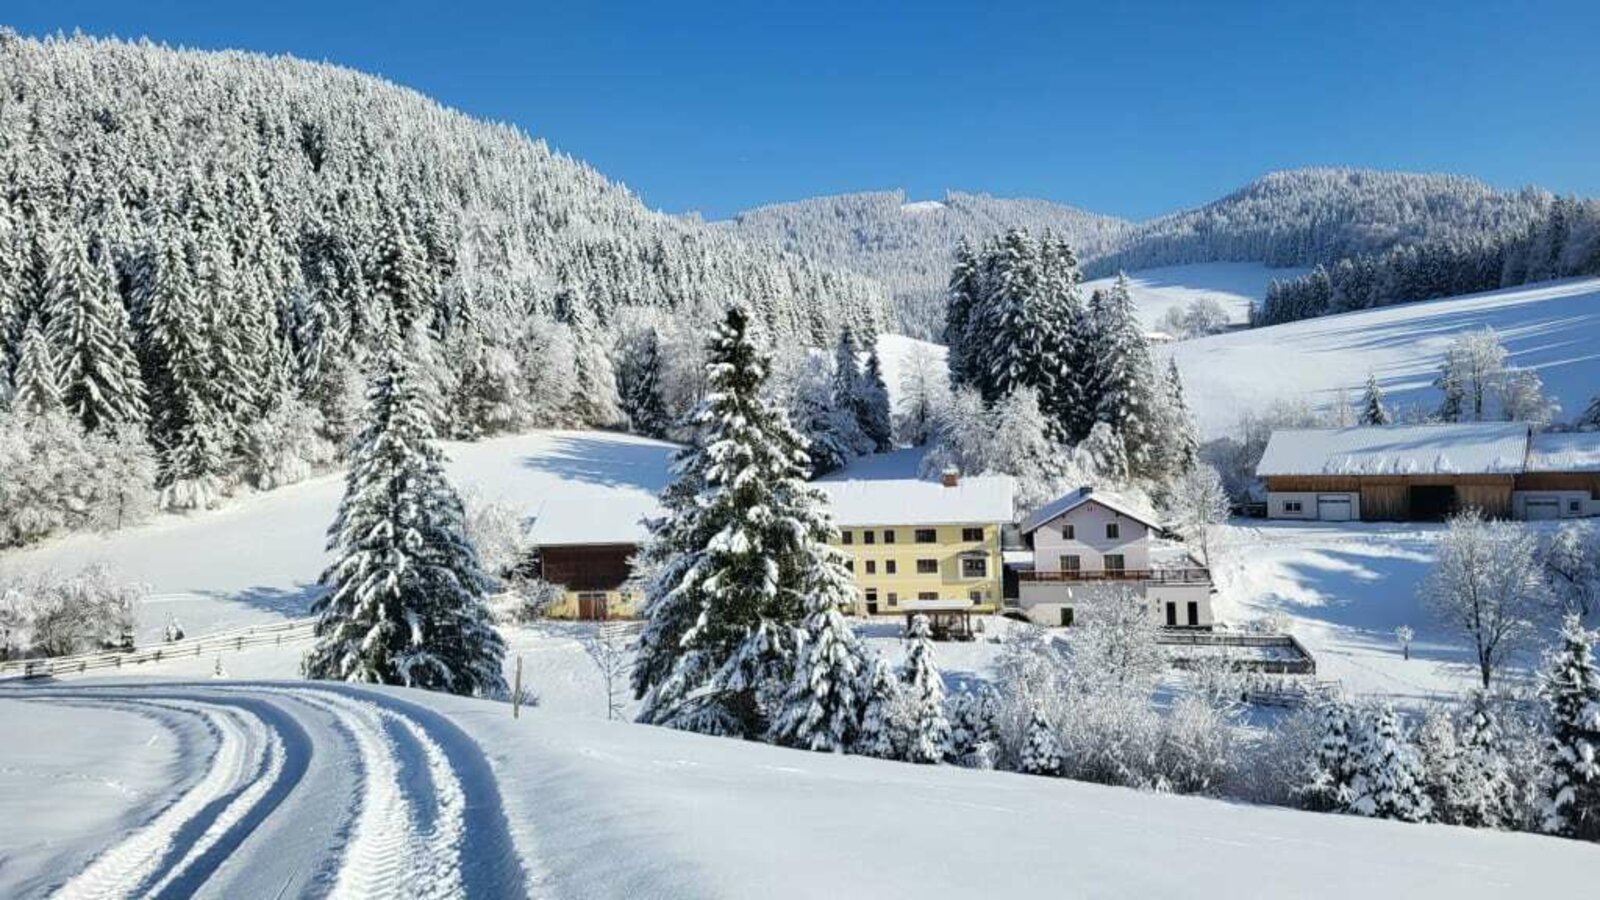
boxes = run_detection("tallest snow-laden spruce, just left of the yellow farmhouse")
[634,306,850,738]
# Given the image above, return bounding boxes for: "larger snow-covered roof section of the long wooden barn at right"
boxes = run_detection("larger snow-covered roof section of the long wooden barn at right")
[1256,421,1528,476]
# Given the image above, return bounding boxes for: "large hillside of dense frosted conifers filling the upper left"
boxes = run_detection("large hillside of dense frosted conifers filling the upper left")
[0,30,888,543]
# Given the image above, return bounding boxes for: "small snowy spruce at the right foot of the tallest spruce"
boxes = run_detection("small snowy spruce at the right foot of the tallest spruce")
[770,560,869,753]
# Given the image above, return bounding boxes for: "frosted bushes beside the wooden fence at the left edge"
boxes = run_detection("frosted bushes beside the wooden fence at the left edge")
[0,565,147,657]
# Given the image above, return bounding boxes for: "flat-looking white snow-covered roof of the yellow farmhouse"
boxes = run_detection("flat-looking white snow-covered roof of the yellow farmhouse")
[816,476,1016,528]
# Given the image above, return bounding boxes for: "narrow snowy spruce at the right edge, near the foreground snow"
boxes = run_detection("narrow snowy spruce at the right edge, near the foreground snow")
[1539,615,1600,841]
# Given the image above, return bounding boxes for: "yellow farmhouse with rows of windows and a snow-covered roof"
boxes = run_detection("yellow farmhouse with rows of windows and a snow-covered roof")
[816,474,1016,615]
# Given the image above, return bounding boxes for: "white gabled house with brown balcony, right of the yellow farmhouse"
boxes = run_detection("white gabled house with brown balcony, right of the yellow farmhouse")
[1016,488,1216,628]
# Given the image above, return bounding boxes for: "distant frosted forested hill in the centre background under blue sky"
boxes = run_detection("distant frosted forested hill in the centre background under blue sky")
[723,191,1131,338]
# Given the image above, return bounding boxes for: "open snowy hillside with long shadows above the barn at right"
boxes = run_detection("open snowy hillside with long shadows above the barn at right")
[1157,279,1600,437]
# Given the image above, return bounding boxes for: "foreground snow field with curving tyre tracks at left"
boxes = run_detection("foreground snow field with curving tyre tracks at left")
[0,679,1600,900]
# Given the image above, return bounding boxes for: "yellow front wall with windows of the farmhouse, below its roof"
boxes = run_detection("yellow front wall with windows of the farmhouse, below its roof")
[834,522,1002,615]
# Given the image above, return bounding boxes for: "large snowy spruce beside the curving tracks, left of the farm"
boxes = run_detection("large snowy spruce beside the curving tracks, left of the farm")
[304,323,506,697]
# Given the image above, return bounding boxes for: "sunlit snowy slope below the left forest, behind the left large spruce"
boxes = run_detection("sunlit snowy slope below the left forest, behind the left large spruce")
[0,431,674,642]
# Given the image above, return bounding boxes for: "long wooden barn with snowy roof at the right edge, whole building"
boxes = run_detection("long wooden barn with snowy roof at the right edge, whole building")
[1256,423,1600,522]
